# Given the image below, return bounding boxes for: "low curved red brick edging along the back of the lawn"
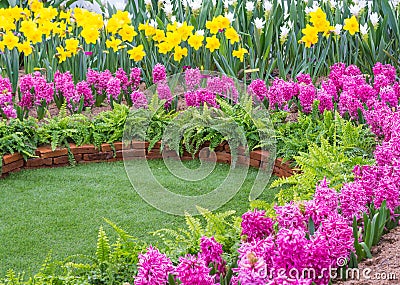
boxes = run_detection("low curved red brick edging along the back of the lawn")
[1,141,293,177]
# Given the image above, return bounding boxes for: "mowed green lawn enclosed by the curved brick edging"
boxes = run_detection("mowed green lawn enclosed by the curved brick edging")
[0,160,277,276]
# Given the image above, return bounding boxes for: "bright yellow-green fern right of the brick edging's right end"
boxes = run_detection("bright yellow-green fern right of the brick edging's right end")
[271,138,373,205]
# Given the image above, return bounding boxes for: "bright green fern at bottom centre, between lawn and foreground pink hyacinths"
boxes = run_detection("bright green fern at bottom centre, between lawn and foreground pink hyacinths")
[153,207,241,261]
